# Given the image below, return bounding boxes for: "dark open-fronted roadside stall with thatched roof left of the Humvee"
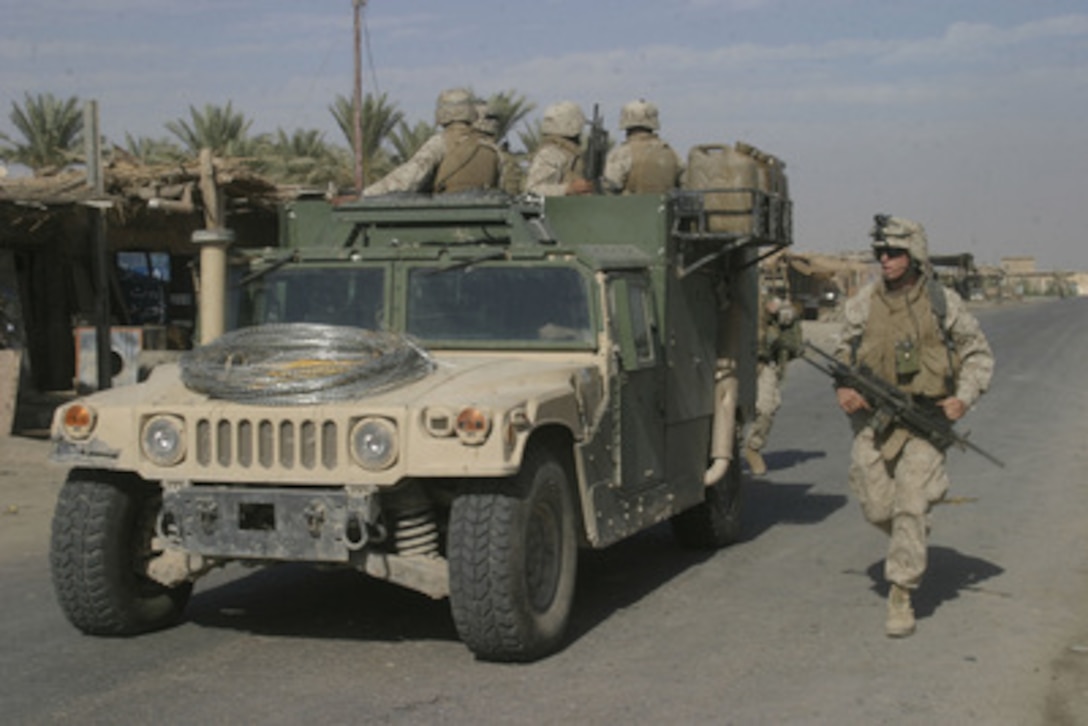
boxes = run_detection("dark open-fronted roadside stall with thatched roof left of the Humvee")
[0,153,284,426]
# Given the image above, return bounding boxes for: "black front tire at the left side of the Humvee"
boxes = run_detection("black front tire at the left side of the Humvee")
[49,469,193,636]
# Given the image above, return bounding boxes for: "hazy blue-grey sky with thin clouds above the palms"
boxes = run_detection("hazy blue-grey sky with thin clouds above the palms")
[0,0,1088,270]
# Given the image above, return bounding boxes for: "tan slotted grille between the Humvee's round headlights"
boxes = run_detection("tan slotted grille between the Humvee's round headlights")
[194,418,341,470]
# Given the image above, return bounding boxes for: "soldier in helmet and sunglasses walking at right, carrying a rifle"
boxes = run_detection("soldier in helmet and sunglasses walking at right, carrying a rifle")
[834,214,993,637]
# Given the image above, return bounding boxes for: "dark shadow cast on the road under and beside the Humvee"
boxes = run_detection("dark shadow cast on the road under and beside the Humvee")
[180,468,846,657]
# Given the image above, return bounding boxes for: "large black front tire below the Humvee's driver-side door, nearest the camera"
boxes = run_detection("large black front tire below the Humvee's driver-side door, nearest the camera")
[448,447,578,661]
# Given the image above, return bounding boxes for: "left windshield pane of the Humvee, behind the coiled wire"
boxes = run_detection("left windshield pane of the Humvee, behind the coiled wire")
[238,266,385,330]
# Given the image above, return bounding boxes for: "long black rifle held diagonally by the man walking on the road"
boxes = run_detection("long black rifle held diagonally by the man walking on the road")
[801,341,1005,469]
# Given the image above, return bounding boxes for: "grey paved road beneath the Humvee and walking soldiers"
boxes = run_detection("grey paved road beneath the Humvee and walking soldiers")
[0,300,1088,725]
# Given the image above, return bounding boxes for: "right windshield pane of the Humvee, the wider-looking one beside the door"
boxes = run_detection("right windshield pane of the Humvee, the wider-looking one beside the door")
[407,264,594,348]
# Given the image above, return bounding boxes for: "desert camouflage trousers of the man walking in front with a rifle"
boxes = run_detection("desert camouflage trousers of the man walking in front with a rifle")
[850,427,949,590]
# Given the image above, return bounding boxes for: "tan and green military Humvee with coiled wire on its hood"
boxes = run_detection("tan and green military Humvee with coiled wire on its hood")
[51,189,790,661]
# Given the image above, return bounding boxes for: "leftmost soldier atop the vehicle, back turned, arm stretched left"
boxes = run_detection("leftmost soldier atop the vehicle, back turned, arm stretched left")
[362,88,502,197]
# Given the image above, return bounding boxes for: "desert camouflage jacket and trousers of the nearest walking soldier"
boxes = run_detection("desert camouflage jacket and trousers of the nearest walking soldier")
[836,276,993,590]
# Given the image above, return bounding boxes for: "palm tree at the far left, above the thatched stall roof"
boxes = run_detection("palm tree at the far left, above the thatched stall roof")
[0,93,83,175]
